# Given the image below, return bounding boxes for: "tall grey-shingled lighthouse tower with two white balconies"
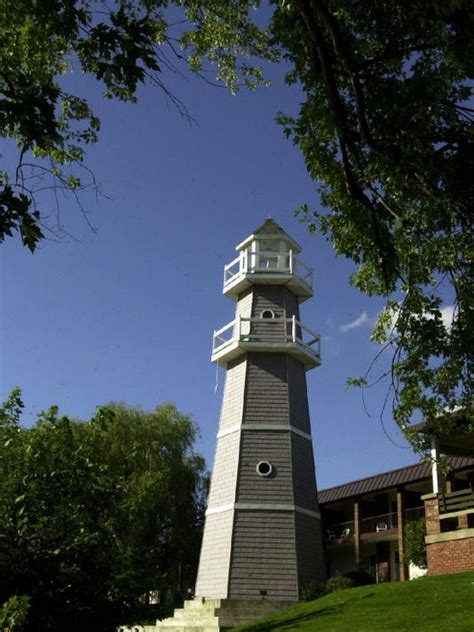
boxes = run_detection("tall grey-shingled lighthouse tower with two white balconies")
[196,219,324,606]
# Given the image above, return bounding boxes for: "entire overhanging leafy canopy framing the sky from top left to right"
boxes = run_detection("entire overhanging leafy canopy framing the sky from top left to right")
[0,0,474,447]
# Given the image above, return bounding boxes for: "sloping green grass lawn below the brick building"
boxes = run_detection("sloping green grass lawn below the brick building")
[234,572,474,632]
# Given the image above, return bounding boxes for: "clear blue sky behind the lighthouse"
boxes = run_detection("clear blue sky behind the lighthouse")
[0,54,417,488]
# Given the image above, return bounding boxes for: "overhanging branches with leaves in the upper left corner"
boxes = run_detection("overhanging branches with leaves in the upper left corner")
[0,0,275,251]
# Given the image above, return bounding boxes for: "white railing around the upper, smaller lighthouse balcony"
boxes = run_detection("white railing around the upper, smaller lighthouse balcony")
[224,249,313,291]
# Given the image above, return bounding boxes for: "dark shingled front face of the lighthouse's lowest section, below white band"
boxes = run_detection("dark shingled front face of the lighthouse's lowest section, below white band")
[229,510,298,601]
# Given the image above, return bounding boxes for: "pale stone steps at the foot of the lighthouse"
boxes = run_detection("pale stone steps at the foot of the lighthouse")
[118,597,295,632]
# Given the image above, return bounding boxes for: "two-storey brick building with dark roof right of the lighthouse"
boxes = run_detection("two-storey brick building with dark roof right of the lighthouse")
[319,456,474,582]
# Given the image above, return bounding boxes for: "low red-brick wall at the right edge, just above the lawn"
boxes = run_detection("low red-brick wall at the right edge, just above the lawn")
[426,537,474,575]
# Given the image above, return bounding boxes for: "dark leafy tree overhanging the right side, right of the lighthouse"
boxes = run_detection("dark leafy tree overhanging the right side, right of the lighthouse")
[271,0,474,439]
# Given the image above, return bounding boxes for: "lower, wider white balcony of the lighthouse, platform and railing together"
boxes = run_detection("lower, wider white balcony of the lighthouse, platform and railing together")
[211,316,321,370]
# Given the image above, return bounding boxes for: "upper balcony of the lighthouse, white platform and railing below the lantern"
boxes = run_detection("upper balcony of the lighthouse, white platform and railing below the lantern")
[223,249,313,302]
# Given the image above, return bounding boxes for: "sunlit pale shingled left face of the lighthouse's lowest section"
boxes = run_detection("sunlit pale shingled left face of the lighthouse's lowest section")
[196,511,234,599]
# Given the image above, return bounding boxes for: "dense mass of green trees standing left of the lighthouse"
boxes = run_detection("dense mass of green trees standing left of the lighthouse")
[0,390,207,632]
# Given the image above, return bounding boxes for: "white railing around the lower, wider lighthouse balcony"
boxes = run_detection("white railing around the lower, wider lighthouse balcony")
[212,316,321,358]
